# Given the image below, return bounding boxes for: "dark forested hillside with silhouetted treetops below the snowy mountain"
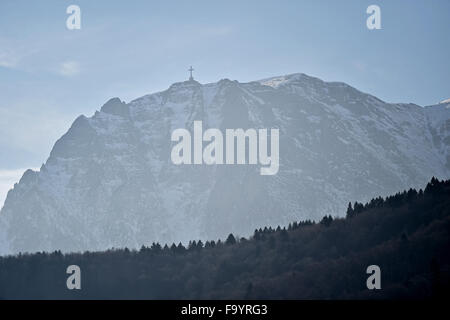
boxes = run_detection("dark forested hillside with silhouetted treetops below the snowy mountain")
[0,178,450,299]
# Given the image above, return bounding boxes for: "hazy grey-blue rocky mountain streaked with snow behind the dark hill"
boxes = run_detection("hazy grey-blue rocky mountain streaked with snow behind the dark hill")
[0,74,450,253]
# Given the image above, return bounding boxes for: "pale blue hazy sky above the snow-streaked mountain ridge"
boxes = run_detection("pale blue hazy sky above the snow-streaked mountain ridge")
[0,0,450,206]
